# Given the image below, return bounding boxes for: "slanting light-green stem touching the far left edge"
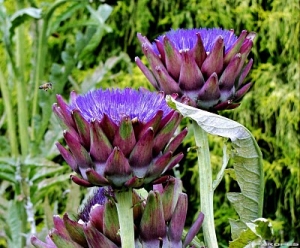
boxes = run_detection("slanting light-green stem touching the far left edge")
[0,69,19,157]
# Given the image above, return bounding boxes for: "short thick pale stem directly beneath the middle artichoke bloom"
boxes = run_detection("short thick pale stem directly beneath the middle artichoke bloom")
[115,189,135,248]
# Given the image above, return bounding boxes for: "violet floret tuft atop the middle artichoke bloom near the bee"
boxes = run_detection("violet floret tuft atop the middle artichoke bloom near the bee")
[68,88,172,125]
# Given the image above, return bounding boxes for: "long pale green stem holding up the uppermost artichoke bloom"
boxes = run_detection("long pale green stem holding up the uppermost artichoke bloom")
[193,121,218,248]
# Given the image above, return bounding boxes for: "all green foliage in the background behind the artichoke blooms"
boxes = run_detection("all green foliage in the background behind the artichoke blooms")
[0,0,300,247]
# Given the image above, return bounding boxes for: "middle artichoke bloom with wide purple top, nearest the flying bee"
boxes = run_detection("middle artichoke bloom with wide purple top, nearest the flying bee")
[53,88,187,188]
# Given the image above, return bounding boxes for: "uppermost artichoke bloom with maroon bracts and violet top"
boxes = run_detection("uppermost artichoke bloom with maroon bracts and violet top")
[136,28,255,112]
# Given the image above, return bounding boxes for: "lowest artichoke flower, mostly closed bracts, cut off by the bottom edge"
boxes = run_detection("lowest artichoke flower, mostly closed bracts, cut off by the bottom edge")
[31,178,204,248]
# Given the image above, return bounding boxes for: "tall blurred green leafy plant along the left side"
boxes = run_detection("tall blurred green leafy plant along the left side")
[0,0,117,247]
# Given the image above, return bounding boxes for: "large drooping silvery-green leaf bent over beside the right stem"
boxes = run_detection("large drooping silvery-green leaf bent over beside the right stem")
[167,96,264,239]
